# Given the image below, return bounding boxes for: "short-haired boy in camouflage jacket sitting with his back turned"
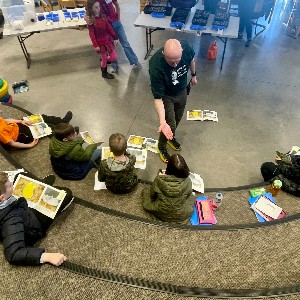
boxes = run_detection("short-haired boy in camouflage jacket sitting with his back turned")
[98,133,138,194]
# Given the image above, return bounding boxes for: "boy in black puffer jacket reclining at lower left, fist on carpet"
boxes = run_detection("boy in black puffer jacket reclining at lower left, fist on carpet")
[0,172,73,267]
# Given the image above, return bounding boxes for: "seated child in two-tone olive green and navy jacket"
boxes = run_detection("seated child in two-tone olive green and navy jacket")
[49,123,101,180]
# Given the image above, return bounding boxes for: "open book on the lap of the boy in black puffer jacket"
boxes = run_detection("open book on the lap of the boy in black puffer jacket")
[13,174,66,219]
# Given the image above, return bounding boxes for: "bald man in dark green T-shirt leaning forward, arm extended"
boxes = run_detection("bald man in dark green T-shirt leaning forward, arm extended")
[149,39,197,163]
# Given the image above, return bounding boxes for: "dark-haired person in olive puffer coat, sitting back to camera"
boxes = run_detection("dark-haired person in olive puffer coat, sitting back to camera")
[142,154,195,223]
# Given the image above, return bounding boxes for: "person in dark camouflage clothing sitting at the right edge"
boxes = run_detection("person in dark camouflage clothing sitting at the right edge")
[261,152,300,197]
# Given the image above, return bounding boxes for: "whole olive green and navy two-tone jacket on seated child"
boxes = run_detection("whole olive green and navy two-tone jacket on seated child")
[49,137,97,180]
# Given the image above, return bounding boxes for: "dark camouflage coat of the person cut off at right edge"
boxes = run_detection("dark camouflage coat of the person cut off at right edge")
[272,155,300,197]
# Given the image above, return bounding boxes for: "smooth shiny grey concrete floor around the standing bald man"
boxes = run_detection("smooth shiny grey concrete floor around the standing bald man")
[0,0,300,188]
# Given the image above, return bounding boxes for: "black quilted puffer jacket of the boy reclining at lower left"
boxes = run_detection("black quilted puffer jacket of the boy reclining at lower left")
[0,198,45,265]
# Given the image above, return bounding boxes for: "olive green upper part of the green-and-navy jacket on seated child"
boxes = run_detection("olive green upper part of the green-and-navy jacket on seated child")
[49,137,97,161]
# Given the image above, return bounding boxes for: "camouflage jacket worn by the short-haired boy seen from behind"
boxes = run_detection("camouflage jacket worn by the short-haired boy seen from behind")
[98,154,138,194]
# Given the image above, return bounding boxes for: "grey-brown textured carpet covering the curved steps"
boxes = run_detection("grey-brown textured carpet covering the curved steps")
[0,106,300,300]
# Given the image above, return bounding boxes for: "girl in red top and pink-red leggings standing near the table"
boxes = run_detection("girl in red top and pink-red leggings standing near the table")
[87,0,118,79]
